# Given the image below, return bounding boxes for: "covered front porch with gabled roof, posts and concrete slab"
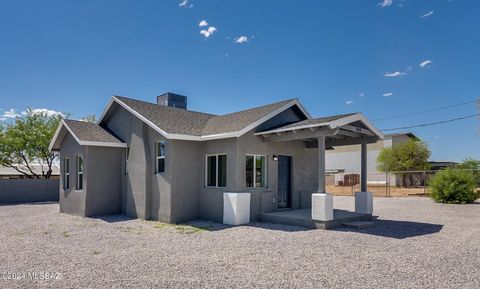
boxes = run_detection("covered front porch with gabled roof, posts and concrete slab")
[256,113,383,229]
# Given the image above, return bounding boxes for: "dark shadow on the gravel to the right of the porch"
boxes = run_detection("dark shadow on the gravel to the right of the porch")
[336,219,443,239]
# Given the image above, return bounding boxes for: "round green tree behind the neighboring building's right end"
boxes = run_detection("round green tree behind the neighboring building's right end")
[377,140,431,186]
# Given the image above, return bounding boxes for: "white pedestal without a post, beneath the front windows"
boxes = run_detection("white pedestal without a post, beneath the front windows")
[223,193,250,226]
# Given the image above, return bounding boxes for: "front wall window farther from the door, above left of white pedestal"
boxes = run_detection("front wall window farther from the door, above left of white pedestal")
[205,154,227,188]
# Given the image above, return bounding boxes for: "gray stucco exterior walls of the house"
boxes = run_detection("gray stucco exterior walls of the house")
[61,104,318,223]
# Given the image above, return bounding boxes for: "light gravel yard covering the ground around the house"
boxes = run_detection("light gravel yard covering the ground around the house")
[0,197,480,288]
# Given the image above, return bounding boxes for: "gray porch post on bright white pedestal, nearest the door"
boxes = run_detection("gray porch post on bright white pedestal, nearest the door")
[312,135,333,221]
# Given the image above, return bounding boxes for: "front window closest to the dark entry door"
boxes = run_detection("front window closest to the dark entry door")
[245,155,267,188]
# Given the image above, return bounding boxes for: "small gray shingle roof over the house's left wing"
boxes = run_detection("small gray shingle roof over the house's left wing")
[64,119,123,143]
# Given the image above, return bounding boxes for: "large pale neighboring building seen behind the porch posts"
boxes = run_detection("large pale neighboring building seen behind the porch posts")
[325,132,419,185]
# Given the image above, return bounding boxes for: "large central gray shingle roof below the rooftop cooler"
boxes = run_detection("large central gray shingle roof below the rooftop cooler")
[115,96,293,136]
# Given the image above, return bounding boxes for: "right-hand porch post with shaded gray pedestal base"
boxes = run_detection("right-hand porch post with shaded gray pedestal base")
[355,143,373,215]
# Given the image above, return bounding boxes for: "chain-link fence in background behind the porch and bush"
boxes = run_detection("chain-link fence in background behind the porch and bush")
[325,170,480,197]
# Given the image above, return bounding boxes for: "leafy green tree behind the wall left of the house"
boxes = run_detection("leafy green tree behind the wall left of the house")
[0,109,64,179]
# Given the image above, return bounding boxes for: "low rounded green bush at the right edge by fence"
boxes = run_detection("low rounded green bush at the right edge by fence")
[429,169,479,204]
